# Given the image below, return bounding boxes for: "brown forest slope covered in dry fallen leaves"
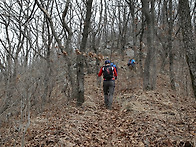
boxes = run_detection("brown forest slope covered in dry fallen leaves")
[0,60,196,147]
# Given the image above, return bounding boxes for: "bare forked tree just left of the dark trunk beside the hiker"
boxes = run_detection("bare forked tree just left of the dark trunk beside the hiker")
[36,0,76,101]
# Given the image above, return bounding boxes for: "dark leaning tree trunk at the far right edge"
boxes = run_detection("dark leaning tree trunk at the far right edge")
[179,0,196,98]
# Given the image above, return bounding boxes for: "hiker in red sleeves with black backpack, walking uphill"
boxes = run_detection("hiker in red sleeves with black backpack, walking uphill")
[98,60,117,110]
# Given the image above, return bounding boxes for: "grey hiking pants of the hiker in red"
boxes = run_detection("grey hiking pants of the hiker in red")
[103,80,115,109]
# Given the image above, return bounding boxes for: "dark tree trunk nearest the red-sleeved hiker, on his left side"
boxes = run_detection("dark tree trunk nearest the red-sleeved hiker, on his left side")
[76,0,93,106]
